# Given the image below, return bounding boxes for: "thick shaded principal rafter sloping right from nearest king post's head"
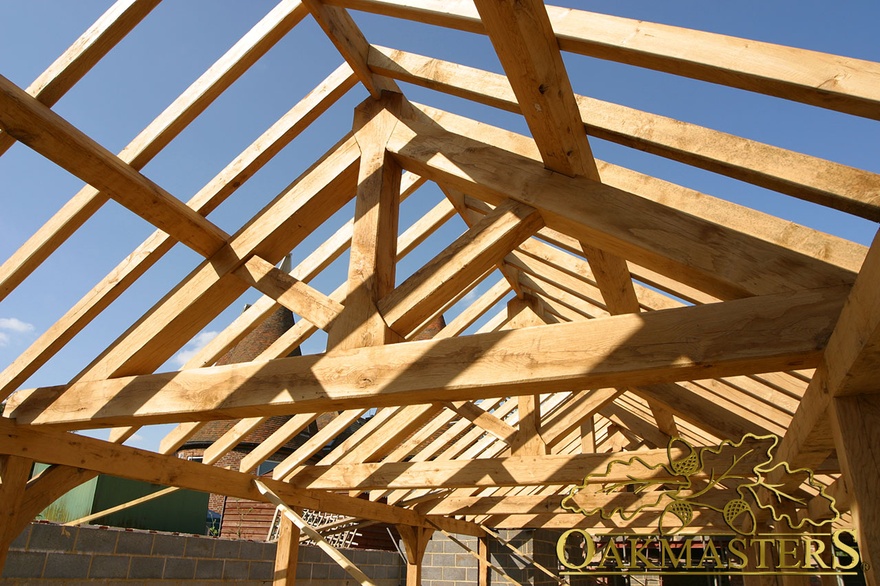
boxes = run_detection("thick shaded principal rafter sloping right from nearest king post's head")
[389,102,854,298]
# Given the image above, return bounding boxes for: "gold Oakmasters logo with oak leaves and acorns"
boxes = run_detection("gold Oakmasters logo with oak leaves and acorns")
[557,434,859,575]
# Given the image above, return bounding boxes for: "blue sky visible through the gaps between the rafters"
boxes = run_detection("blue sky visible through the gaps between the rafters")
[0,0,880,443]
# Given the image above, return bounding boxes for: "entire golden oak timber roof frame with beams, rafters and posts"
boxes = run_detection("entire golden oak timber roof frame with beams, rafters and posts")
[0,0,880,586]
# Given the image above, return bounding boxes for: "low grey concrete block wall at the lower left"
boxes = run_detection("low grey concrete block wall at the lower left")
[0,523,406,586]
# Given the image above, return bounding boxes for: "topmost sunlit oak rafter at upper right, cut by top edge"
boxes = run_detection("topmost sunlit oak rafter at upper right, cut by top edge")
[336,0,880,120]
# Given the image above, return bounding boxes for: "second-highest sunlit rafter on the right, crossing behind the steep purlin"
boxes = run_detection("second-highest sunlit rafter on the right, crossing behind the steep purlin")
[369,46,880,221]
